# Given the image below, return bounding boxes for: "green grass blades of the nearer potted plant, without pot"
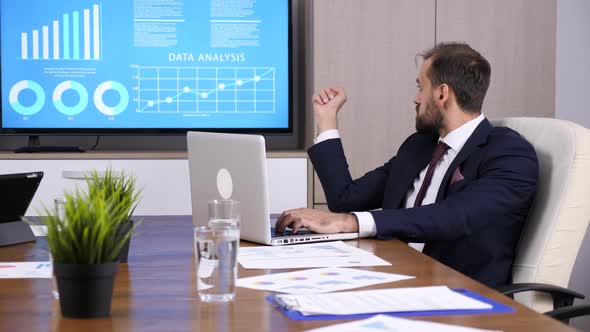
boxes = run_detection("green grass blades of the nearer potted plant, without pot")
[41,190,137,264]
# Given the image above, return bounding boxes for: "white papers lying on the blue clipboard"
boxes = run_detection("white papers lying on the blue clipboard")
[275,286,492,316]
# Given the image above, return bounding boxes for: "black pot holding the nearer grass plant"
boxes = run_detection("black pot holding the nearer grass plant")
[53,262,119,318]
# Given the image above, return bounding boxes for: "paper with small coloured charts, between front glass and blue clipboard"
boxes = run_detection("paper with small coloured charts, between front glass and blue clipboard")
[237,268,414,294]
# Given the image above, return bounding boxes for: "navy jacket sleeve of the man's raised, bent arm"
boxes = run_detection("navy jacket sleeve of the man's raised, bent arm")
[308,139,393,212]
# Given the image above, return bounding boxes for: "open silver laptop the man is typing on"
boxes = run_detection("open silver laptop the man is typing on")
[187,132,358,245]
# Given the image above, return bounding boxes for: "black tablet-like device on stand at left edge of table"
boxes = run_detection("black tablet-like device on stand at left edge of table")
[0,172,43,246]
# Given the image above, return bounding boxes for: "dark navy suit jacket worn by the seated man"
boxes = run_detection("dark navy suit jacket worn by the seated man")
[308,120,538,287]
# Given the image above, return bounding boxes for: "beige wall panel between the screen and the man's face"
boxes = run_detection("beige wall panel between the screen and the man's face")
[309,0,435,203]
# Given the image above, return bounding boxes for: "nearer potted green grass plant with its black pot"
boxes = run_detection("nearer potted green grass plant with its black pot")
[41,190,137,318]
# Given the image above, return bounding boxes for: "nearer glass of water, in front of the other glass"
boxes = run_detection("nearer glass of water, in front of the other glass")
[194,224,240,302]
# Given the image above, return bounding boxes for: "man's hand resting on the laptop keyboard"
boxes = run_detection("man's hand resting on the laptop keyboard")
[275,209,358,234]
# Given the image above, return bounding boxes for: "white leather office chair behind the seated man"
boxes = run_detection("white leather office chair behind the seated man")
[491,117,590,312]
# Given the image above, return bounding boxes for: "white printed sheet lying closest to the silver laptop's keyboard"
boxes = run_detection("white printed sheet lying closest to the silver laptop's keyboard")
[238,241,391,269]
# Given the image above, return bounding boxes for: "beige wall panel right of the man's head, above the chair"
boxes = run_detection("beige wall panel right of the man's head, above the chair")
[436,0,556,118]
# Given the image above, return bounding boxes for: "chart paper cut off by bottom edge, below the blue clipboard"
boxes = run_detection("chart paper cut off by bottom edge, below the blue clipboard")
[307,315,499,332]
